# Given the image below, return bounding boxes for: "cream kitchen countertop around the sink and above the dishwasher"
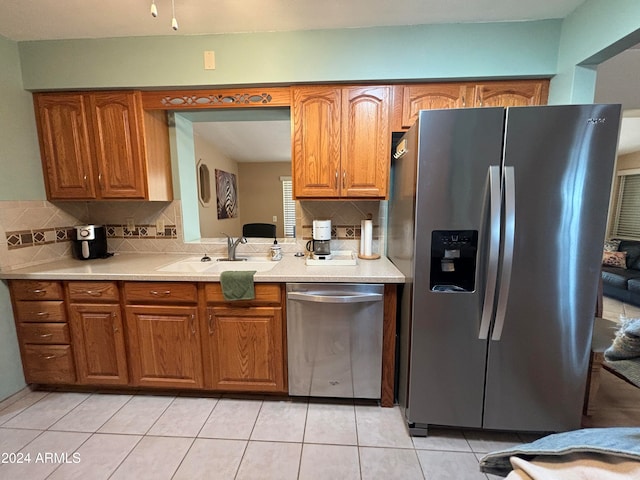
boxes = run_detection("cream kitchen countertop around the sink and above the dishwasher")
[0,253,404,283]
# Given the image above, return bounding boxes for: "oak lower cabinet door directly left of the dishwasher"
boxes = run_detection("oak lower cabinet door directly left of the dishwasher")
[207,307,286,392]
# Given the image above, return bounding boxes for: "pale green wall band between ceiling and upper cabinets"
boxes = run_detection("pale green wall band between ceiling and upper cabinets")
[19,20,561,90]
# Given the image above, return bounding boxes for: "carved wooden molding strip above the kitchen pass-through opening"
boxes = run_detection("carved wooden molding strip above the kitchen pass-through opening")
[142,87,291,110]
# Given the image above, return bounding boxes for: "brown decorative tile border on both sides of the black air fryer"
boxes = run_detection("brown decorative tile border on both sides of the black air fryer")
[6,225,178,250]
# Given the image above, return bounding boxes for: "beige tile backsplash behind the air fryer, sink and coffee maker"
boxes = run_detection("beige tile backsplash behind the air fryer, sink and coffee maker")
[0,197,387,270]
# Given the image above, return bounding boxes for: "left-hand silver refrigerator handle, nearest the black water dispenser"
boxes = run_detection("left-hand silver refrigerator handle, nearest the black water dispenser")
[478,165,501,340]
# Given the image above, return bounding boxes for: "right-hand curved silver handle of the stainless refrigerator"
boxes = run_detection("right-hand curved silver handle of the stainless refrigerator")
[491,167,516,341]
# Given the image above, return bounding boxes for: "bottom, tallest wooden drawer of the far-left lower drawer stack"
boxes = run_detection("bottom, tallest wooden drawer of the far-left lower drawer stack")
[23,345,76,383]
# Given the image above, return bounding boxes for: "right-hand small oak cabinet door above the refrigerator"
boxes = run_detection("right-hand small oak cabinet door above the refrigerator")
[473,81,548,107]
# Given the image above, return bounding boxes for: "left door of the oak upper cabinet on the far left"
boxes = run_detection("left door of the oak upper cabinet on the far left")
[33,94,96,200]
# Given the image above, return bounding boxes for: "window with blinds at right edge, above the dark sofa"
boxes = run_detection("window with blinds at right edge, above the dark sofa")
[612,169,640,240]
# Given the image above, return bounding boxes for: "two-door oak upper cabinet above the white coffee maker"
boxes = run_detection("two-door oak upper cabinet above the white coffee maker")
[292,86,391,198]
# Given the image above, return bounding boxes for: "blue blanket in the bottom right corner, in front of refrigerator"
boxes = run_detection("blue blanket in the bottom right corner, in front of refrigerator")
[480,427,640,477]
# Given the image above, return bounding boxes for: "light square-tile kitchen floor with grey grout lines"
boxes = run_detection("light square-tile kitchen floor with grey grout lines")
[0,389,532,480]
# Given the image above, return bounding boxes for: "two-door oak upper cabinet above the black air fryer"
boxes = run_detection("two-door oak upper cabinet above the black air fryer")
[34,91,173,200]
